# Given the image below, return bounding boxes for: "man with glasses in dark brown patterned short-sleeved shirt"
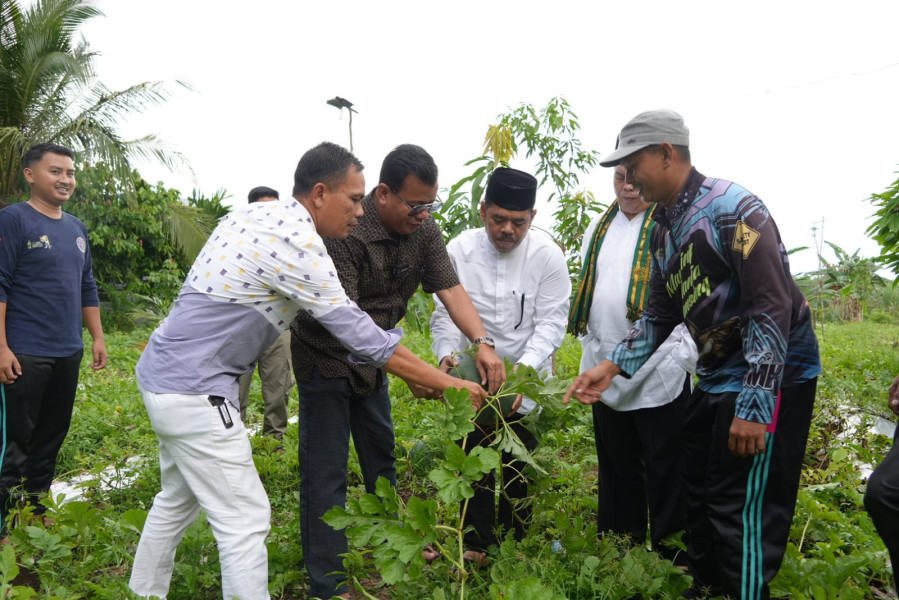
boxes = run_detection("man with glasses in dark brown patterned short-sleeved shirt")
[291,144,505,598]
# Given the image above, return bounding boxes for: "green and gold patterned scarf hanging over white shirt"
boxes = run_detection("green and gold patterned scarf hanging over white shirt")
[568,200,656,336]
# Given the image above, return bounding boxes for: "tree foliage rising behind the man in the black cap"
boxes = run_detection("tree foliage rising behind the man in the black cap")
[435,97,605,272]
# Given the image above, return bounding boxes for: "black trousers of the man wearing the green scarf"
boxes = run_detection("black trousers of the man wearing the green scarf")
[593,378,690,560]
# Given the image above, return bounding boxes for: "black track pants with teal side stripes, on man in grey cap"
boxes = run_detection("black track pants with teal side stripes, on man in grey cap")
[684,379,817,600]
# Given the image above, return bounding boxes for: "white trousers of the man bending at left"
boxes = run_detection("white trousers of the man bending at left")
[129,390,271,600]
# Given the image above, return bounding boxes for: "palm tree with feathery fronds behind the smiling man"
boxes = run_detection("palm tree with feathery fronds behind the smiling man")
[0,0,184,208]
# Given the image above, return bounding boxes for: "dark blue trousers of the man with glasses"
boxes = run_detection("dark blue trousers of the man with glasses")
[297,370,396,598]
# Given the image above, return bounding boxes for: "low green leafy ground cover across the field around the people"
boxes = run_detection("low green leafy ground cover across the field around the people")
[0,322,899,600]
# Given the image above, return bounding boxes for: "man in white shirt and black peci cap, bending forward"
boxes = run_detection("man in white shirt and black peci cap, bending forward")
[431,167,571,561]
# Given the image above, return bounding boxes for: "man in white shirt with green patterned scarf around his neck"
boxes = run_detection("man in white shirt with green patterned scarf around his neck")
[568,166,696,559]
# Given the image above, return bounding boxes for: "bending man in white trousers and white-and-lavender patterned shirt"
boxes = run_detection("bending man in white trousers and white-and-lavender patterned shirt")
[129,143,484,600]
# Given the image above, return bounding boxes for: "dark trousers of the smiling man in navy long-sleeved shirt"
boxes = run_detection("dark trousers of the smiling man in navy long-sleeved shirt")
[0,350,83,529]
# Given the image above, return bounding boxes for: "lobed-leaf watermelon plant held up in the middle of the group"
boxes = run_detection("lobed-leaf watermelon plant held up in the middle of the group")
[324,360,565,598]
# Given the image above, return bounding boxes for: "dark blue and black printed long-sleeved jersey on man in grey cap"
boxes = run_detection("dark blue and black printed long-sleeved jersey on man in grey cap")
[609,169,821,423]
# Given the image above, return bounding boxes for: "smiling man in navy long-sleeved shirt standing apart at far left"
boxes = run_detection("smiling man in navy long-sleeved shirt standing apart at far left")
[0,144,107,531]
